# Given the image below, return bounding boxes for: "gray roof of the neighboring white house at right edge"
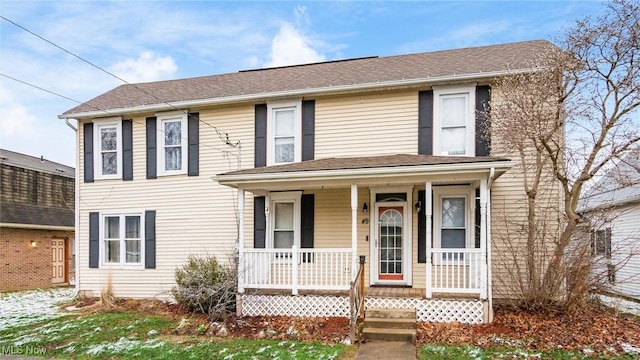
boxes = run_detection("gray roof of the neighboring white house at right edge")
[578,150,640,211]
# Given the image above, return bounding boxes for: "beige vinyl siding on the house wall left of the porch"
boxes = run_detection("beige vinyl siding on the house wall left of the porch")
[78,105,254,297]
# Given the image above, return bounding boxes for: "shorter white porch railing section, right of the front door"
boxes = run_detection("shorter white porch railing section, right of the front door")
[427,249,484,297]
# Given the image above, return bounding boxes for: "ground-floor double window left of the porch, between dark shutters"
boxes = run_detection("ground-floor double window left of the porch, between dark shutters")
[102,213,143,265]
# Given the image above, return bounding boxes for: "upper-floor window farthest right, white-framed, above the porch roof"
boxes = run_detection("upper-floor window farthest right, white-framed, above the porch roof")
[433,85,475,156]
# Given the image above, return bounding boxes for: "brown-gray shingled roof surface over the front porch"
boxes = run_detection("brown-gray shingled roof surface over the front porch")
[220,154,509,177]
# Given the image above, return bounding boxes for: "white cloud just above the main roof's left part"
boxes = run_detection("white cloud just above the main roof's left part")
[109,51,178,83]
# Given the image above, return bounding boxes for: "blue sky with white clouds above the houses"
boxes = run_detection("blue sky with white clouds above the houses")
[0,0,604,166]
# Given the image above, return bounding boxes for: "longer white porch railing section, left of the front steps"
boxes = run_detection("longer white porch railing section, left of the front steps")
[239,247,353,294]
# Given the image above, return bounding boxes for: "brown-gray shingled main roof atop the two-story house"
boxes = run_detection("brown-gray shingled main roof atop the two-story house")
[60,40,553,117]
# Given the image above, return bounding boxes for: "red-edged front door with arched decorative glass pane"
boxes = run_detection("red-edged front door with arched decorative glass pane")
[378,206,405,281]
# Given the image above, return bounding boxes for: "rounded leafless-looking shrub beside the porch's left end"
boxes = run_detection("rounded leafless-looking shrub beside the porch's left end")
[171,255,237,320]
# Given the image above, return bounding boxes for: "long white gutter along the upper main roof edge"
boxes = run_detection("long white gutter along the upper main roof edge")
[58,68,542,119]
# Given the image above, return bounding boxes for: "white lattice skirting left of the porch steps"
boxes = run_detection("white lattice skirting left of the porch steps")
[240,295,349,317]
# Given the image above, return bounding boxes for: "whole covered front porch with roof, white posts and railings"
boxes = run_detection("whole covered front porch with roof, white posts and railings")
[218,155,512,323]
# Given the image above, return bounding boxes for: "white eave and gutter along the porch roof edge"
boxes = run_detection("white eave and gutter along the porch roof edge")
[215,160,515,188]
